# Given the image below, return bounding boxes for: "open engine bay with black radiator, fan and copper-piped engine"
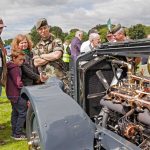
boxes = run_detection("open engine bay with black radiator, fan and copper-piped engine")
[77,42,150,150]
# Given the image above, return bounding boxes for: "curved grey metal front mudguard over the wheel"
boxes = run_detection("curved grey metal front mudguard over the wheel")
[22,80,95,150]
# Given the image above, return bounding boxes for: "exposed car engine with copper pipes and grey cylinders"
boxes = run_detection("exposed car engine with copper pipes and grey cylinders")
[98,59,150,150]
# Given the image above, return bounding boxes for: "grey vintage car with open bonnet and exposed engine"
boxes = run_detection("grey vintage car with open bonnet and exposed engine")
[22,39,150,150]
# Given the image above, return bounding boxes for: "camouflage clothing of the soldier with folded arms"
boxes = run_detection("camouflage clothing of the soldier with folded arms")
[33,36,66,79]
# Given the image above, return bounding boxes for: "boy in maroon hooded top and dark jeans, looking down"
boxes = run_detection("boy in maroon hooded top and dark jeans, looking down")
[6,51,27,140]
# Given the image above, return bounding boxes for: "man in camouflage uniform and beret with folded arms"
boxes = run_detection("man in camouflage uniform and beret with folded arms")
[33,18,67,91]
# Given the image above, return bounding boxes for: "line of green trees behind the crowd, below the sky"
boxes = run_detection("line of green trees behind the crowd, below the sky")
[4,24,150,46]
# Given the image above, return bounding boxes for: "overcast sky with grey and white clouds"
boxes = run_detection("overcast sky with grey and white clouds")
[0,0,150,39]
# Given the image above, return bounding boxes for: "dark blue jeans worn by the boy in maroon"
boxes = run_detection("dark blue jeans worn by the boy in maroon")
[11,97,27,135]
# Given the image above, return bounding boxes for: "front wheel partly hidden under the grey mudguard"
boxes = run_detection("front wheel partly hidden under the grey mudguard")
[26,105,41,150]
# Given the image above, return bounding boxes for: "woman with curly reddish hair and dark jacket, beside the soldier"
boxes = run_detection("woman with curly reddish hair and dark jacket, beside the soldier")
[11,34,47,86]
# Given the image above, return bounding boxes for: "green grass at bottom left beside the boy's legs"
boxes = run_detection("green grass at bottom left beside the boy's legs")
[0,90,28,150]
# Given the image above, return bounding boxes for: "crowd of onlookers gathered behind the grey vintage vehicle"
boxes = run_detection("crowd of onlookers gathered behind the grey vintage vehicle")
[0,18,149,140]
